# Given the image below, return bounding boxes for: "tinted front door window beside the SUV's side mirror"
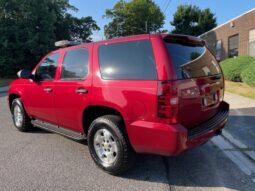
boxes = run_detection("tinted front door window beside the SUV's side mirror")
[35,53,59,81]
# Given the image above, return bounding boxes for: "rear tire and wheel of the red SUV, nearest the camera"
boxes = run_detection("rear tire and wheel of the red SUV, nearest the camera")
[88,115,135,175]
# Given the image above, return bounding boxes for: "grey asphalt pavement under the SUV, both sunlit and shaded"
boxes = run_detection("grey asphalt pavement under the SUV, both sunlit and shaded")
[0,93,255,191]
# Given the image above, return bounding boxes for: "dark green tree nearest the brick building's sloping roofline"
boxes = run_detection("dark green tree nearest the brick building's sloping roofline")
[170,5,217,36]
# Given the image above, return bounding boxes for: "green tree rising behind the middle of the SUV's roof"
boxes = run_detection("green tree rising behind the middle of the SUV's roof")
[104,0,165,38]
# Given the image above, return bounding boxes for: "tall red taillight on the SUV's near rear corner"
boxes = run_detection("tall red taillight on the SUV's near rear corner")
[158,81,179,124]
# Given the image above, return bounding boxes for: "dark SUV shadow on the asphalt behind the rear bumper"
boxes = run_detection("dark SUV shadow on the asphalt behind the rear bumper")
[119,142,255,191]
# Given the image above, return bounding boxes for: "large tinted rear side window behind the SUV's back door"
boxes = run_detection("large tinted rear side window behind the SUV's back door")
[99,40,157,80]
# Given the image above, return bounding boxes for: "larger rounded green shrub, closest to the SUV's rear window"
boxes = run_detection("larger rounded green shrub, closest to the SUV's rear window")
[221,56,255,82]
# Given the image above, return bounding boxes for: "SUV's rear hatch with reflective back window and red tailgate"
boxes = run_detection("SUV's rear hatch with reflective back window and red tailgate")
[164,35,224,128]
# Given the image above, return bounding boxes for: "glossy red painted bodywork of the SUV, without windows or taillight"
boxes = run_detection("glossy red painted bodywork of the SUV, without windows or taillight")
[9,35,229,155]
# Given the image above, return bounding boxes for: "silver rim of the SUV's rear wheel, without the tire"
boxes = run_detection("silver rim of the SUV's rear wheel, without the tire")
[94,129,118,167]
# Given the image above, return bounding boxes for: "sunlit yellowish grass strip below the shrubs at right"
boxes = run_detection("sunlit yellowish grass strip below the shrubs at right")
[225,80,255,99]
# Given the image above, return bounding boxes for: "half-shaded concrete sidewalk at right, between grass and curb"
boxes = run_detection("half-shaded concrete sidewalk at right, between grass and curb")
[223,92,255,160]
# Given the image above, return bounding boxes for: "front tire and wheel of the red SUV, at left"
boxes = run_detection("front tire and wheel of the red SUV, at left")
[11,98,32,132]
